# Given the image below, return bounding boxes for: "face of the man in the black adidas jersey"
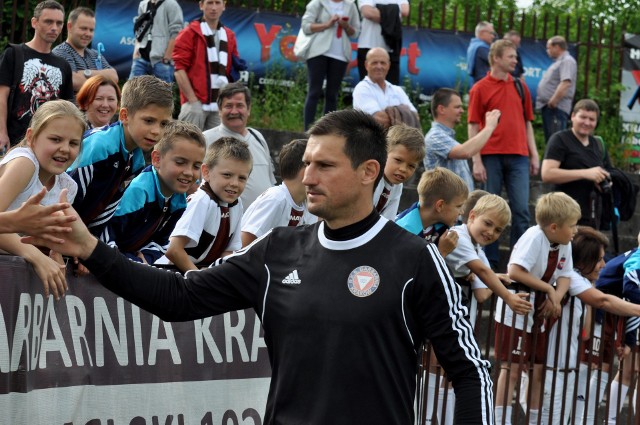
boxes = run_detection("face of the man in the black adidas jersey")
[302,134,362,227]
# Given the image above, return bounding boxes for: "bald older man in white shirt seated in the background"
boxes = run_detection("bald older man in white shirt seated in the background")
[353,47,418,128]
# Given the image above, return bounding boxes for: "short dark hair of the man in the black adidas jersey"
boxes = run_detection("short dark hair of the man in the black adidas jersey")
[307,109,387,185]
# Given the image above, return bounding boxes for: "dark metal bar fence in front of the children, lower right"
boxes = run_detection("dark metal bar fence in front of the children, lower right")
[416,290,640,425]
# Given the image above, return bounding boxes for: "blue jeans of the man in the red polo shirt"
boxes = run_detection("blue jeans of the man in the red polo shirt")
[482,155,529,267]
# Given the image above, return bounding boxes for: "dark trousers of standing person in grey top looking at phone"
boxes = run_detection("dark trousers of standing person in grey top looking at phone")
[304,55,347,131]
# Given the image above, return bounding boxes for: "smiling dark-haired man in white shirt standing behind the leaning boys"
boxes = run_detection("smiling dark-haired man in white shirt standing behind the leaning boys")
[204,83,276,208]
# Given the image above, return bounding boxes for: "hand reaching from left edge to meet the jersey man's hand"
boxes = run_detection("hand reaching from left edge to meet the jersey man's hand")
[8,188,77,243]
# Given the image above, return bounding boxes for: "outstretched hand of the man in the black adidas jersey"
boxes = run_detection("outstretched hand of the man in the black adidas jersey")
[22,191,98,259]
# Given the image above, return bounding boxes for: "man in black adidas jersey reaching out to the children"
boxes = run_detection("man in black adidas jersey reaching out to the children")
[25,110,494,425]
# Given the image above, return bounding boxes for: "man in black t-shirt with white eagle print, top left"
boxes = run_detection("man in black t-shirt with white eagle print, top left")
[0,0,74,150]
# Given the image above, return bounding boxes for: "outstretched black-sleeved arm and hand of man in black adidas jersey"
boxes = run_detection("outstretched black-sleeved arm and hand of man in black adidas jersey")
[22,190,261,321]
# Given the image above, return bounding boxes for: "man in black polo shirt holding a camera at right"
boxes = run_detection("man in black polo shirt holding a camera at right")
[541,99,611,229]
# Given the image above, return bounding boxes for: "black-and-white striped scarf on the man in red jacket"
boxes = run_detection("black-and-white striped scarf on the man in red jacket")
[200,21,229,111]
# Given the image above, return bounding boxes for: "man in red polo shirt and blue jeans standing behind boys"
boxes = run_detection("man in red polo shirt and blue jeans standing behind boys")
[468,40,540,268]
